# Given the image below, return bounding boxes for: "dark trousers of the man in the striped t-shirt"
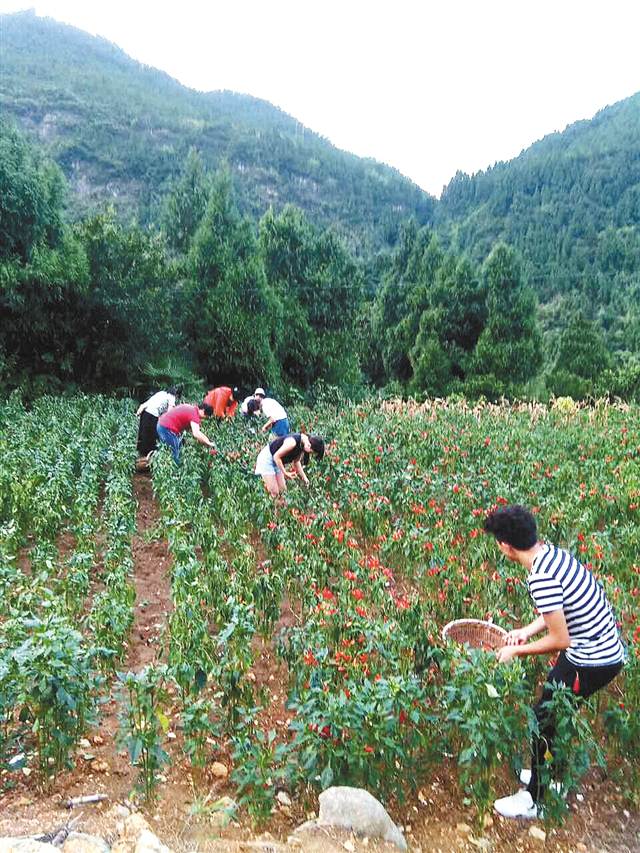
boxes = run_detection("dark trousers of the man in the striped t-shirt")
[527,652,622,802]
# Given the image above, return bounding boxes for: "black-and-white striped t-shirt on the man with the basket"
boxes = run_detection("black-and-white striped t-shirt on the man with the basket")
[527,545,624,666]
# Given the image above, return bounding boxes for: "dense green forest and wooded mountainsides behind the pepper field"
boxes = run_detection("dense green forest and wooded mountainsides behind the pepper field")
[0,14,640,399]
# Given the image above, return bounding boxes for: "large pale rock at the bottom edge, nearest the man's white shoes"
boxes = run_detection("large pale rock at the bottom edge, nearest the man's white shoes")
[317,786,407,850]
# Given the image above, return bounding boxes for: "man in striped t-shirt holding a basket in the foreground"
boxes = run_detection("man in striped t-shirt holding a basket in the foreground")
[484,505,625,818]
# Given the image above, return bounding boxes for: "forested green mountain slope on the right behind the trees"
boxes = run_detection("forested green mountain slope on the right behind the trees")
[436,93,640,342]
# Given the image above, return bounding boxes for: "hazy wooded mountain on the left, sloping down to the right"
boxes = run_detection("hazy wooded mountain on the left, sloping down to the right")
[0,12,435,251]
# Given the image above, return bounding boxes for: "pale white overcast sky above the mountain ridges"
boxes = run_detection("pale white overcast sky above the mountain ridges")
[0,0,640,195]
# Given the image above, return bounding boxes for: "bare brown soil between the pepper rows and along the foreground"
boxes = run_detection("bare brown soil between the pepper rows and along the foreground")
[0,474,640,853]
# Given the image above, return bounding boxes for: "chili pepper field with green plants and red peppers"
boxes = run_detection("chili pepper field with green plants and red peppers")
[0,395,640,850]
